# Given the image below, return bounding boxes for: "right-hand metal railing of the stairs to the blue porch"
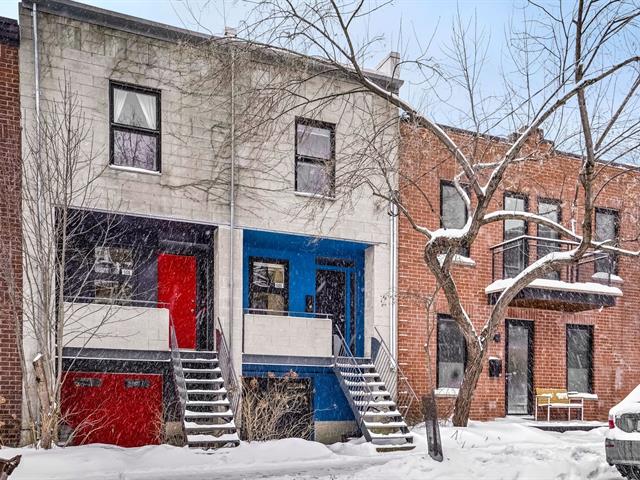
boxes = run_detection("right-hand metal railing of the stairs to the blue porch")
[372,327,420,421]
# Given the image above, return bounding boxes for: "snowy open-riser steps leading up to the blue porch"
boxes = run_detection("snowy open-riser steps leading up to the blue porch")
[333,356,415,452]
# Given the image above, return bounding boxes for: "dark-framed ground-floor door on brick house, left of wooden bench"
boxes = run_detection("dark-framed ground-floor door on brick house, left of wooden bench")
[506,320,533,415]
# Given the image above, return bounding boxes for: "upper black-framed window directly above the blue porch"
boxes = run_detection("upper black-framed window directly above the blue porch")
[295,118,336,197]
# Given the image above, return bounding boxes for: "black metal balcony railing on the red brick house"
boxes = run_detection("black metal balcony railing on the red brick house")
[490,235,617,285]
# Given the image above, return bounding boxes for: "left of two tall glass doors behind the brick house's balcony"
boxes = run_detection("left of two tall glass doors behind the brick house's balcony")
[502,192,529,278]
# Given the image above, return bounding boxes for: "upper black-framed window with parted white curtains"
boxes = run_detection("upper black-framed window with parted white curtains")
[110,83,160,172]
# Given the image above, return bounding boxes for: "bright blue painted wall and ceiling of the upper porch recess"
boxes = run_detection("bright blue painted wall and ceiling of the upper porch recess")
[243,230,369,356]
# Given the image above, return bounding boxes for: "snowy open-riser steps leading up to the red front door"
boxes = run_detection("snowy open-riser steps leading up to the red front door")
[180,350,240,449]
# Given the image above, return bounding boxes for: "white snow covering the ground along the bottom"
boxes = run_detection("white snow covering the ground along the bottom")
[0,420,621,480]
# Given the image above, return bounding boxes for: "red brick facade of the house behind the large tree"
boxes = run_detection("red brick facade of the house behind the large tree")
[398,125,640,419]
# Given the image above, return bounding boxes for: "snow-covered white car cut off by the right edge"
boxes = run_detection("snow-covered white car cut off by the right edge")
[605,385,640,480]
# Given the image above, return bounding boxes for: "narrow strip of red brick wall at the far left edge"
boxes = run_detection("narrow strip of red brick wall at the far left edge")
[0,17,22,445]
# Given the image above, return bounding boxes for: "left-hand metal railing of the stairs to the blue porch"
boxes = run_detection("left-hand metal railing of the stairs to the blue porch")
[333,330,373,442]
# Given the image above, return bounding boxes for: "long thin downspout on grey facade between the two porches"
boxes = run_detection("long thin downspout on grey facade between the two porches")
[225,28,236,352]
